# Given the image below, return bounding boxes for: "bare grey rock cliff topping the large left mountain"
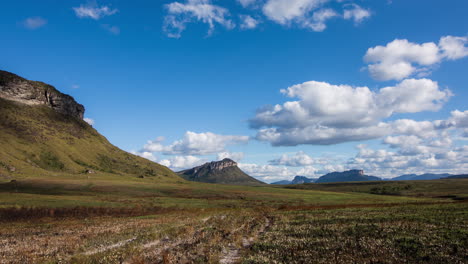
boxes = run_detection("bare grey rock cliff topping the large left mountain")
[0,71,85,119]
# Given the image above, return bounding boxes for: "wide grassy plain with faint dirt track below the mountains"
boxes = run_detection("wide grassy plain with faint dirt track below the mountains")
[0,173,468,263]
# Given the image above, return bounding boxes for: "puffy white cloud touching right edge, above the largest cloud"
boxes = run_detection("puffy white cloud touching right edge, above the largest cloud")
[364,36,468,81]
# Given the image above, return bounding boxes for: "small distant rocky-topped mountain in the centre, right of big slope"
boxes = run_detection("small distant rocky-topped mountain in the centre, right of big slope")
[178,159,264,185]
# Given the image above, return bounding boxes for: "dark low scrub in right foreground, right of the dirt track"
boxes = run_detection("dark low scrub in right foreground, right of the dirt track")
[244,203,468,263]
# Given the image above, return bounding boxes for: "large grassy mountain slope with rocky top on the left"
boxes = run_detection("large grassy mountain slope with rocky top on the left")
[0,71,182,181]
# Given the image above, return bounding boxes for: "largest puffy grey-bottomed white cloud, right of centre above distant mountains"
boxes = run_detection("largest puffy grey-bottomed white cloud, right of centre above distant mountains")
[249,79,452,146]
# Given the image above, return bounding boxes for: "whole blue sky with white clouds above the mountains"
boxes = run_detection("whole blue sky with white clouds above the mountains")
[0,0,468,182]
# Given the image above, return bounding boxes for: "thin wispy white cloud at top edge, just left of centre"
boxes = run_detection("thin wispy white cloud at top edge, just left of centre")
[164,0,235,38]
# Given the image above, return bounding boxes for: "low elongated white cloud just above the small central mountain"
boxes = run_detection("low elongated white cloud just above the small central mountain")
[143,131,249,155]
